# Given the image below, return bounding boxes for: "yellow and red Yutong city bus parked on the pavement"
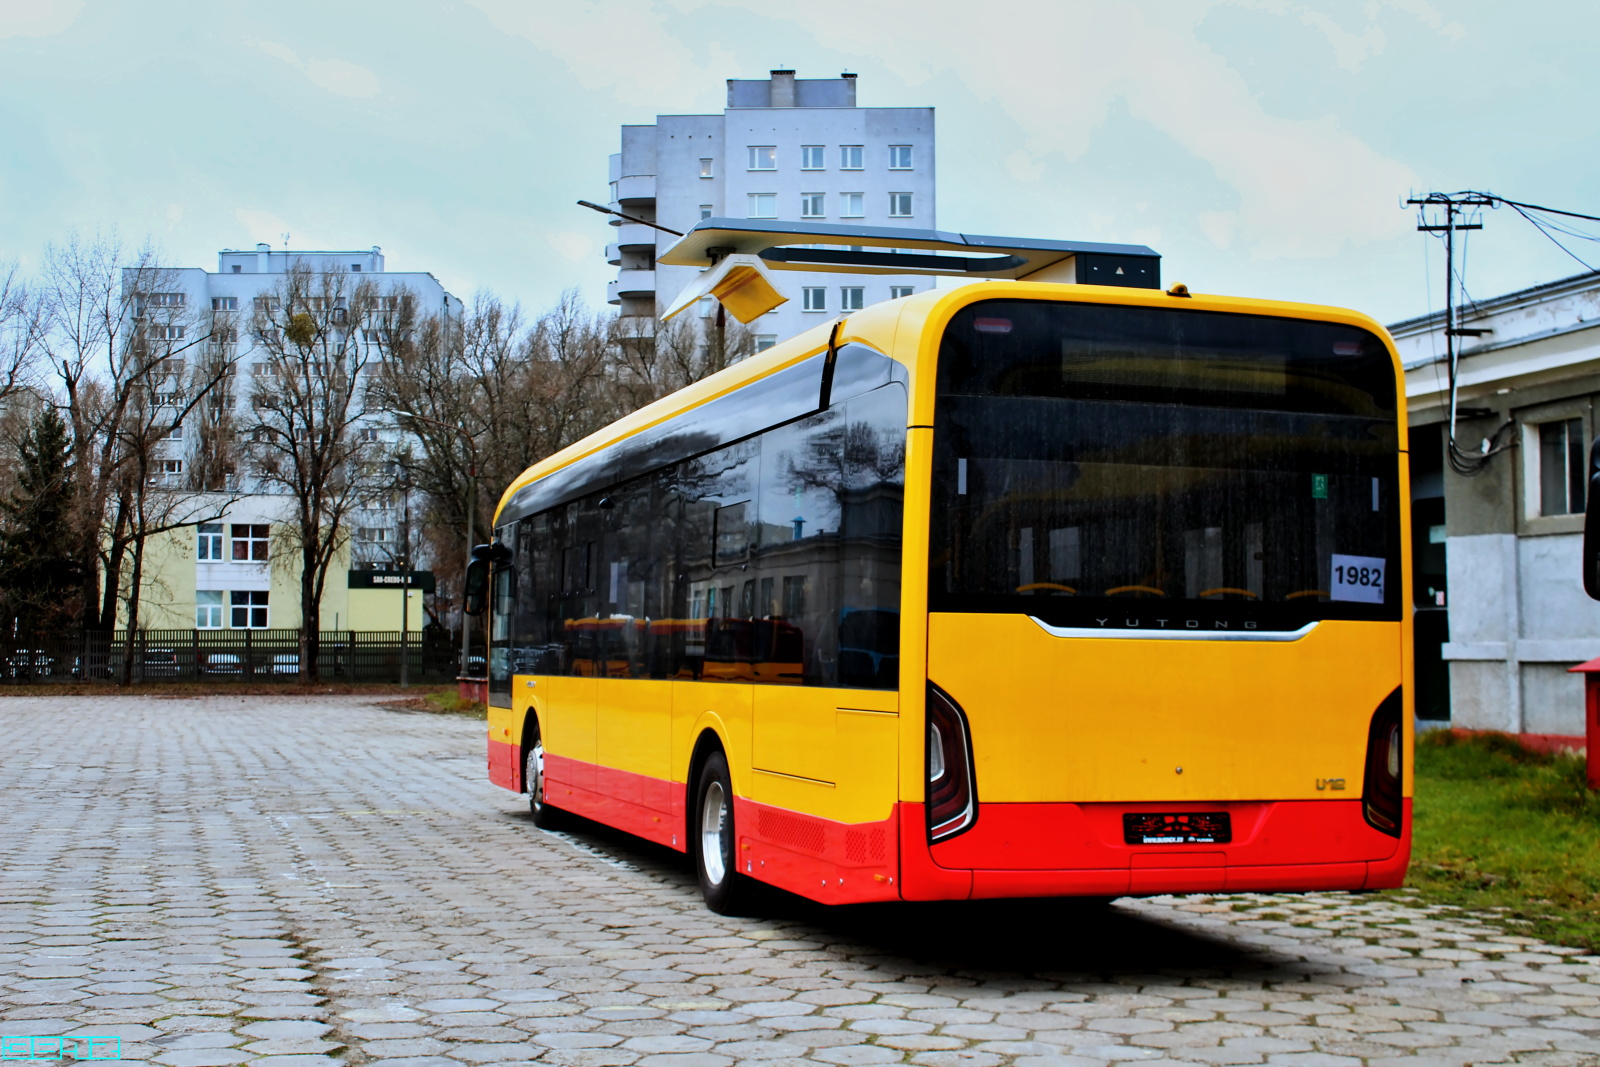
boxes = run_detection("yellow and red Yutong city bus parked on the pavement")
[480,271,1411,910]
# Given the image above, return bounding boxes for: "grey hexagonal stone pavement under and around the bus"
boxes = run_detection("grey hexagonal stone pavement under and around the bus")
[0,696,1600,1067]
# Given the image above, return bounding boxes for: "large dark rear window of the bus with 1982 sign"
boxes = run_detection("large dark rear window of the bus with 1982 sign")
[930,301,1400,630]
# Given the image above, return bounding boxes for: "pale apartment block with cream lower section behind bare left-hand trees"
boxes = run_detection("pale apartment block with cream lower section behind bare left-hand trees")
[125,245,462,630]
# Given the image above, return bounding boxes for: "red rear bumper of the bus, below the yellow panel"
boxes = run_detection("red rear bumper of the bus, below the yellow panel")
[901,798,1411,899]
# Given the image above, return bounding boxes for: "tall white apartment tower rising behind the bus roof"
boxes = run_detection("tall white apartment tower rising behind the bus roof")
[606,70,938,349]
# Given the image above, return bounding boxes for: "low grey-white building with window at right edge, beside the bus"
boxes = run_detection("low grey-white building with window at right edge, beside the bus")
[1389,274,1600,737]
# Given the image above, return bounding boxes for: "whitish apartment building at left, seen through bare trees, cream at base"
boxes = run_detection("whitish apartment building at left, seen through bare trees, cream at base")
[123,245,462,630]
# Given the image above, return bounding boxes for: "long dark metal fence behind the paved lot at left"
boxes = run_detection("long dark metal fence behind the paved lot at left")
[0,630,483,685]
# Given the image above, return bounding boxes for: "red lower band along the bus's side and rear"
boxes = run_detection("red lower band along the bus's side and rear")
[488,741,1411,904]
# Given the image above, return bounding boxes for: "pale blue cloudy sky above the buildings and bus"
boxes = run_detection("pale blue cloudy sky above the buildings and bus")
[0,0,1600,323]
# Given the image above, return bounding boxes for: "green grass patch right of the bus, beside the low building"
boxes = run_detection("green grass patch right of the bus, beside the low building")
[1397,729,1600,952]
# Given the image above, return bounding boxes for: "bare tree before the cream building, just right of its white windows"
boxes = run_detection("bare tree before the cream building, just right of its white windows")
[248,264,403,681]
